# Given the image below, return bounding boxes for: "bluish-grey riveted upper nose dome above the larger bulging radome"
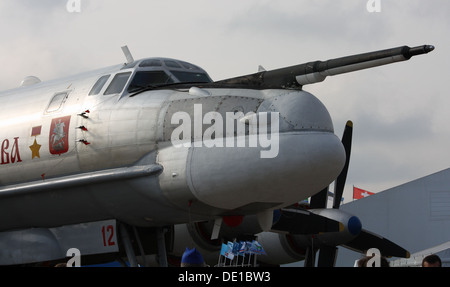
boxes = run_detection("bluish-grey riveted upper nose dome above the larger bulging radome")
[258,91,334,132]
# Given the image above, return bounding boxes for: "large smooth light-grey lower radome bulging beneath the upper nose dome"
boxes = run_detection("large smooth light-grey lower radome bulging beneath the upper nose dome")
[189,132,344,212]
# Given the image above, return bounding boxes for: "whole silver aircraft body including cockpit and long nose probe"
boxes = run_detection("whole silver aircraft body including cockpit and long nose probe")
[0,46,433,265]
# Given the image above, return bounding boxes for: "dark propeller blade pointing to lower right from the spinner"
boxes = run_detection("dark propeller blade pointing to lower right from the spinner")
[343,229,410,258]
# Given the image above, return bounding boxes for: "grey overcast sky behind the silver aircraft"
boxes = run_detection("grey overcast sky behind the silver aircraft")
[0,0,450,204]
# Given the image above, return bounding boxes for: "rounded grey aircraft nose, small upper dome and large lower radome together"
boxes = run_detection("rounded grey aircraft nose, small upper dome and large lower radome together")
[187,91,345,211]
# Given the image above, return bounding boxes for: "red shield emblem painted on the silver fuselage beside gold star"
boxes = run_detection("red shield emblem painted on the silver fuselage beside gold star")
[49,116,70,155]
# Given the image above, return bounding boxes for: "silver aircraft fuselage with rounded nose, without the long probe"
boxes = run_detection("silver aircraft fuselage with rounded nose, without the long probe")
[0,57,345,233]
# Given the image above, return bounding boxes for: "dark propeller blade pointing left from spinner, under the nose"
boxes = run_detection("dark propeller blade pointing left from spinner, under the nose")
[272,209,344,235]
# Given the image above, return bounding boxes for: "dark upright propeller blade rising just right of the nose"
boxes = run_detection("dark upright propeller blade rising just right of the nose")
[333,121,353,209]
